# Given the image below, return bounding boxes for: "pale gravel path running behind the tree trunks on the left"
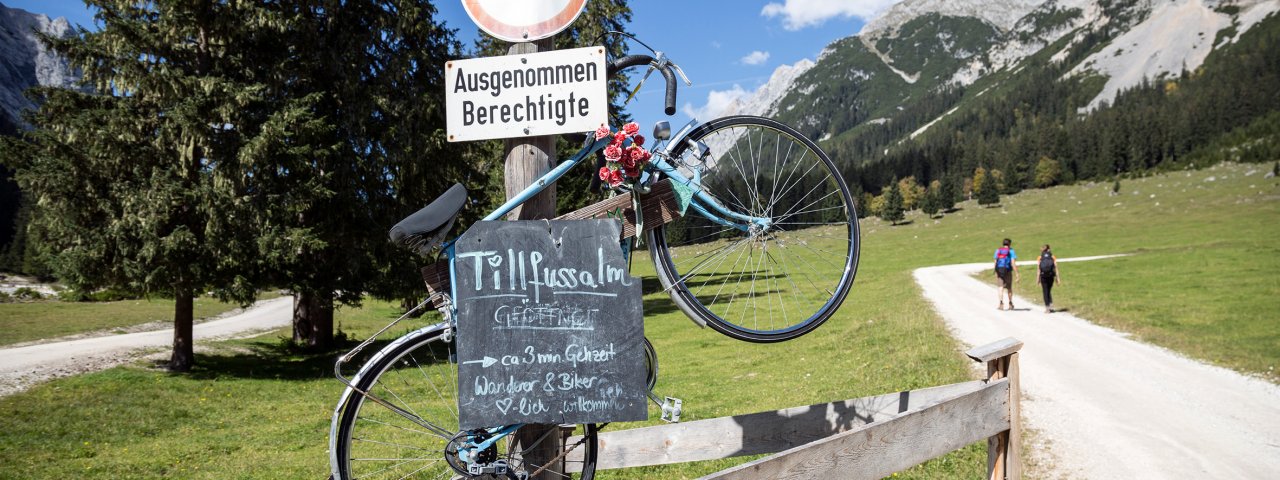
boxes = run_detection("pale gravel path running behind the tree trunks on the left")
[0,297,293,396]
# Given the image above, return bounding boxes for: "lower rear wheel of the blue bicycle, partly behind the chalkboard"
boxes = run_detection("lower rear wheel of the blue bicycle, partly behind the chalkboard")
[332,324,596,480]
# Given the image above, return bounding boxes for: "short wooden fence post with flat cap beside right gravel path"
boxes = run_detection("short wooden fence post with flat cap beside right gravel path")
[965,338,1023,480]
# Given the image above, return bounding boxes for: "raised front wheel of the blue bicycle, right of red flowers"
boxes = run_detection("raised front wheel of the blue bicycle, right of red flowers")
[649,116,859,342]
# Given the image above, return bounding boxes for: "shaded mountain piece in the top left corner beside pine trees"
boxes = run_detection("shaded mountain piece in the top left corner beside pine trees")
[0,4,79,129]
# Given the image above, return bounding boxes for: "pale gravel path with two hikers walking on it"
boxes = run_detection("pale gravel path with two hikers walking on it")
[915,257,1280,479]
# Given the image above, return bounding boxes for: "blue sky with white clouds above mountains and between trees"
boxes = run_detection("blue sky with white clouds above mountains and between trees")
[0,0,899,135]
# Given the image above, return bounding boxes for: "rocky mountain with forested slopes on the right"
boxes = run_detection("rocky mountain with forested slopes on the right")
[736,0,1280,199]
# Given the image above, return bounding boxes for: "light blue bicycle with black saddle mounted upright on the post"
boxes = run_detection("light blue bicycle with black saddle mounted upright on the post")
[329,37,859,479]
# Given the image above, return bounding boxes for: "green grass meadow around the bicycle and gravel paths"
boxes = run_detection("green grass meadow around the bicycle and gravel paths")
[0,165,1280,479]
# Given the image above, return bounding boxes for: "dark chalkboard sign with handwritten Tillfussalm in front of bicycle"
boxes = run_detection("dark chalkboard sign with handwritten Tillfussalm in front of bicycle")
[453,220,648,429]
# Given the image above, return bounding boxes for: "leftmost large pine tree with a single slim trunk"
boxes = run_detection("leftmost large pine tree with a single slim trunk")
[6,0,279,371]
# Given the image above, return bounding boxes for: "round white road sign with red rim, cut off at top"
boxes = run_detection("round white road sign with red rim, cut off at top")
[462,0,586,42]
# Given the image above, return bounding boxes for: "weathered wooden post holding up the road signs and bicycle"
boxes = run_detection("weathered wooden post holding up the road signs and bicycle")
[503,37,567,480]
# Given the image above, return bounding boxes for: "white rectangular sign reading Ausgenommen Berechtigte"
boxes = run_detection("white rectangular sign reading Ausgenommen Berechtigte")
[444,46,609,142]
